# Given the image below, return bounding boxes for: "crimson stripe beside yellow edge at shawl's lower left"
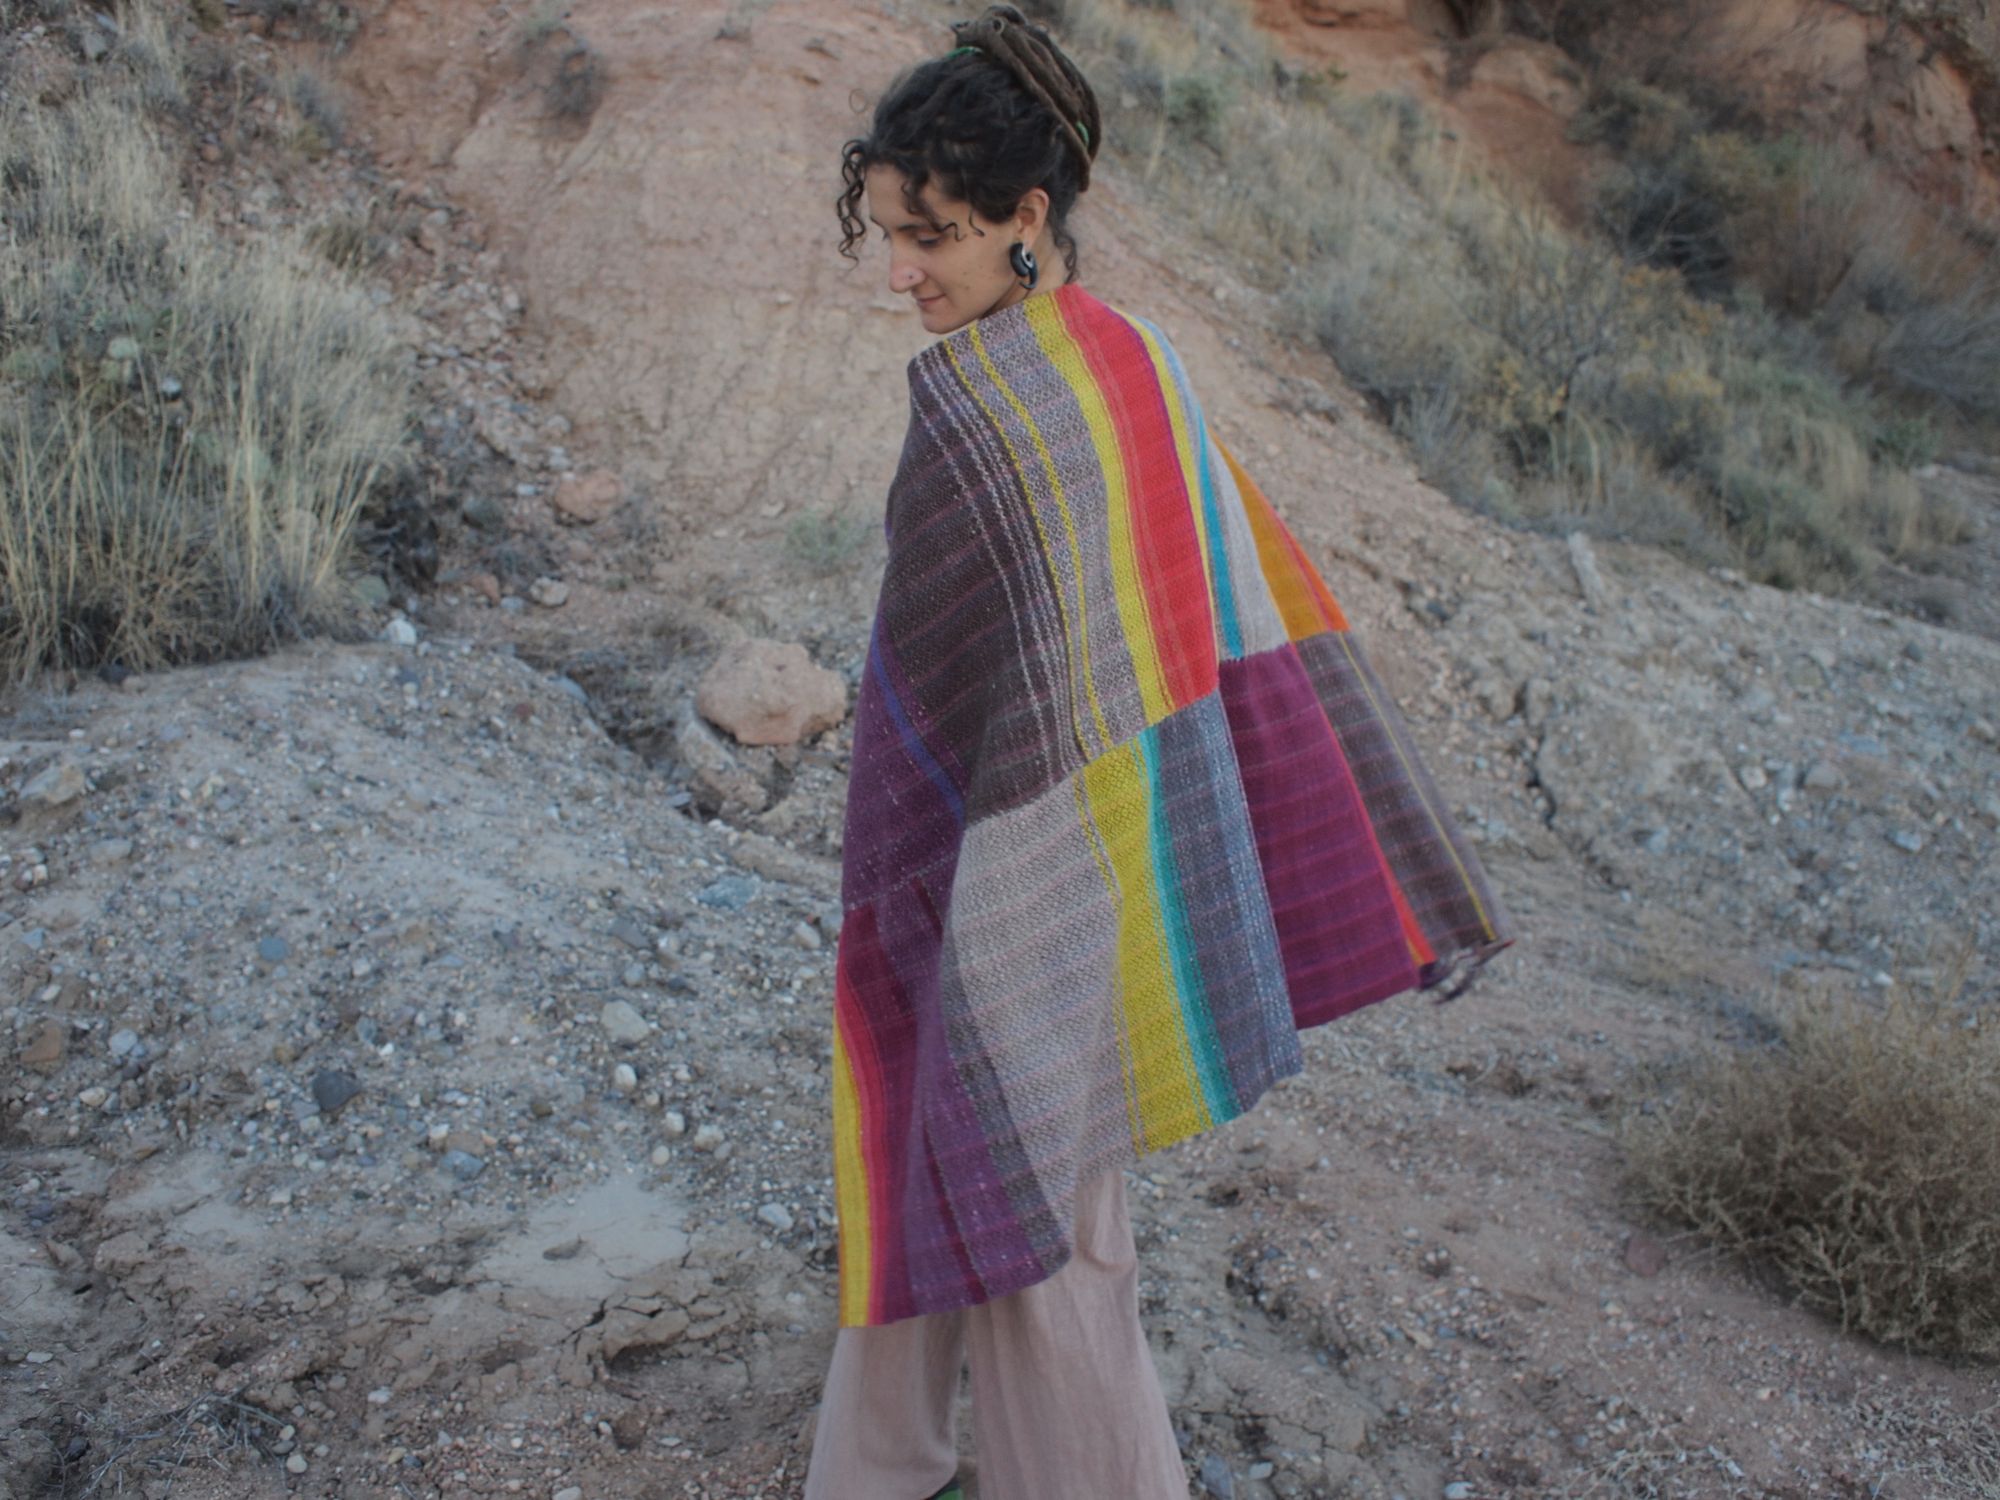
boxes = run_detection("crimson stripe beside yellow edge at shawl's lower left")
[834,906,914,1324]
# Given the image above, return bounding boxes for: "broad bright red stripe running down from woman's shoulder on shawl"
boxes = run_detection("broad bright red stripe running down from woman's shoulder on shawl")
[1056,298,1216,708]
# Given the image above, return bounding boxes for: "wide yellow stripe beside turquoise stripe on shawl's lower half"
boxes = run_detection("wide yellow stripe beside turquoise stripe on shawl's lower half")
[1078,742,1210,1152]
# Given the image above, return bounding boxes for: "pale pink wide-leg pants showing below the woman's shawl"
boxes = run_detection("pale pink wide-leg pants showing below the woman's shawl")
[806,1172,1188,1500]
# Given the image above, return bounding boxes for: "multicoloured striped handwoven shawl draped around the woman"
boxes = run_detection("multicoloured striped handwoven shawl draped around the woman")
[834,284,1512,1326]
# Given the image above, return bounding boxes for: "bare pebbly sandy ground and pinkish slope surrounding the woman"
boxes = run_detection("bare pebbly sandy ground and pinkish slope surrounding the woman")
[0,0,2000,1500]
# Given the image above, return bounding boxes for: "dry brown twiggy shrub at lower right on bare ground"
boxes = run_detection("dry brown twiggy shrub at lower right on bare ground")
[1624,968,2000,1356]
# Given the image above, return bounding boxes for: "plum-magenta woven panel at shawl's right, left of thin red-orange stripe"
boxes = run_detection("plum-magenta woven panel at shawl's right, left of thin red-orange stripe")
[1222,644,1416,1030]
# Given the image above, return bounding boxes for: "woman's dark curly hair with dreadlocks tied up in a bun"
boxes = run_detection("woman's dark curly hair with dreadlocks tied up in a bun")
[836,6,1104,278]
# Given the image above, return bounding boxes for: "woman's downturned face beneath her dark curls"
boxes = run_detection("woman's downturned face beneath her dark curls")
[866,166,1048,334]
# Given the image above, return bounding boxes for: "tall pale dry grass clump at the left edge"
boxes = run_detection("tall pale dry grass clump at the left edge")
[0,16,408,682]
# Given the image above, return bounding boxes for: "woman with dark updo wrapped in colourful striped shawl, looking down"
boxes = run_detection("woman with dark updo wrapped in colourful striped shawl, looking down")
[806,6,1510,1500]
